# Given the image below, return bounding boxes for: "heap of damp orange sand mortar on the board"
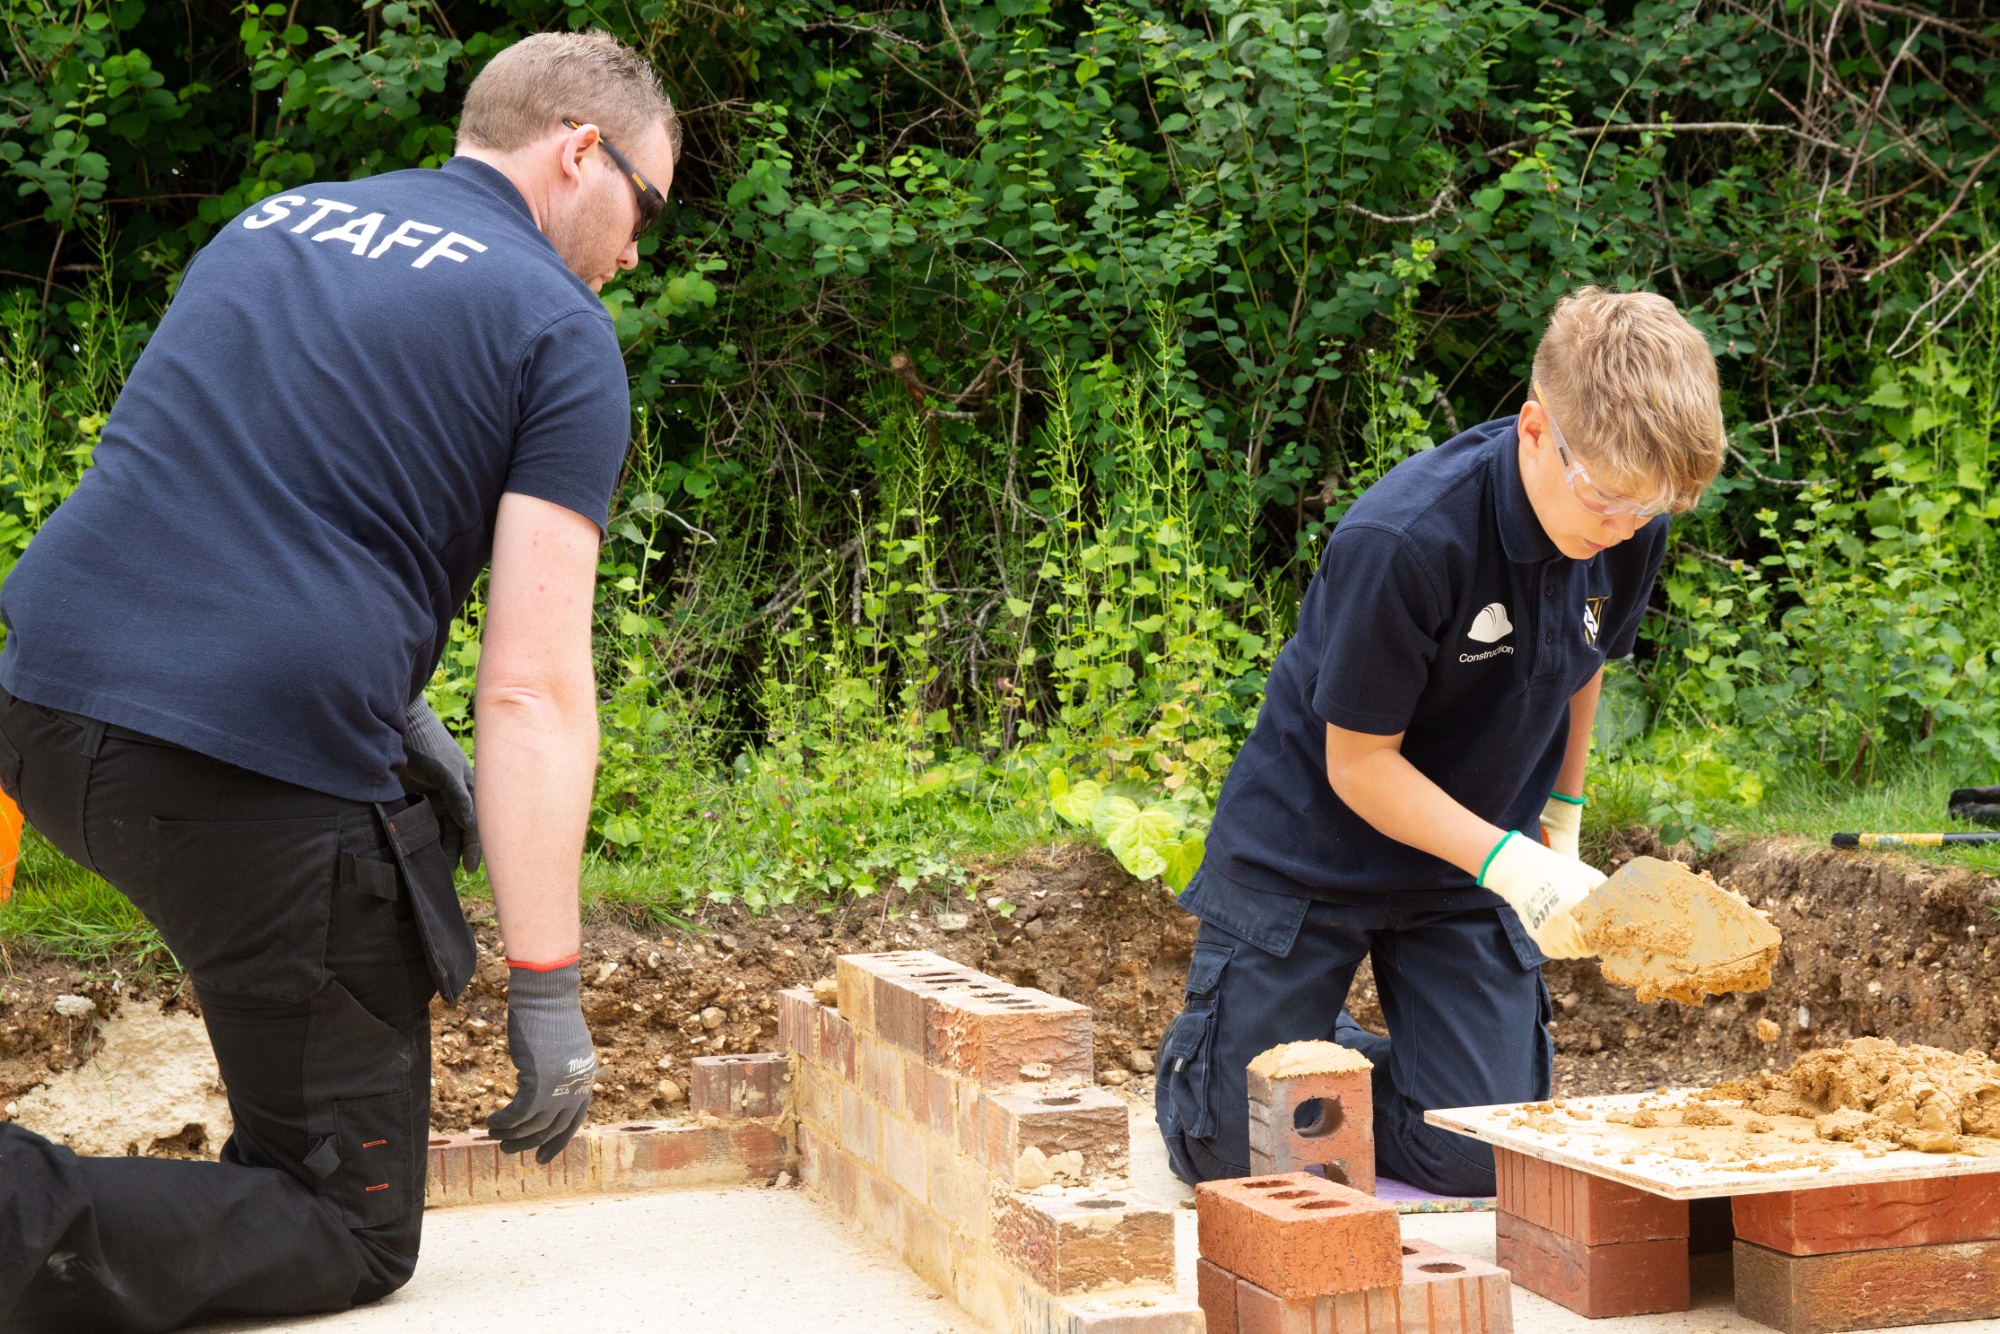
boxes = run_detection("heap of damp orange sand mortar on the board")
[1702,1038,2000,1154]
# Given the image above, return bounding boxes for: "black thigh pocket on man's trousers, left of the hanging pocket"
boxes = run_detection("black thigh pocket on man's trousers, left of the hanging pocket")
[146,816,340,1000]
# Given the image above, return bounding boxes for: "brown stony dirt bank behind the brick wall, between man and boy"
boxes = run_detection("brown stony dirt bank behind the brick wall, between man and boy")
[432,844,1194,1130]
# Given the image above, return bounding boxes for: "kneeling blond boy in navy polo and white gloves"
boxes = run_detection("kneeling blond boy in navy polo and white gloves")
[1156,288,1724,1196]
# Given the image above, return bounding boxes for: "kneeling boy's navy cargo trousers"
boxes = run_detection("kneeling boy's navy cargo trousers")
[1154,872,1554,1196]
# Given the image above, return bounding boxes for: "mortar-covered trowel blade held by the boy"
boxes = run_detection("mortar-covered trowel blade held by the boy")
[1574,856,1780,1006]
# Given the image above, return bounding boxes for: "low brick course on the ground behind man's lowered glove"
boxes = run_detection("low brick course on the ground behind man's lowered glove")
[424,1122,792,1208]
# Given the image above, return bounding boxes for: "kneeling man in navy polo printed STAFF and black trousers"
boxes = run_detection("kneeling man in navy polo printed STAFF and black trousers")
[0,34,678,1334]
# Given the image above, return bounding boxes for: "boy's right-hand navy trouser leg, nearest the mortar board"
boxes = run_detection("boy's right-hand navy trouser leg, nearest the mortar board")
[1374,910,1554,1196]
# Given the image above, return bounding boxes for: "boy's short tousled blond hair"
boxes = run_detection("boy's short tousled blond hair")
[1534,288,1726,510]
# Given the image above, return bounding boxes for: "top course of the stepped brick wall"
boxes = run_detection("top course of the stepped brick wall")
[836,950,1094,1086]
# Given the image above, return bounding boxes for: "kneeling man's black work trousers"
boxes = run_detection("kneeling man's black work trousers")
[0,692,434,1334]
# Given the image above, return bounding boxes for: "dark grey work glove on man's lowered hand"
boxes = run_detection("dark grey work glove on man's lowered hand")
[486,964,598,1162]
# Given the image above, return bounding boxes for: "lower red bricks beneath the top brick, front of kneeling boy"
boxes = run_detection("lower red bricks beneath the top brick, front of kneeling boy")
[1194,1238,1514,1334]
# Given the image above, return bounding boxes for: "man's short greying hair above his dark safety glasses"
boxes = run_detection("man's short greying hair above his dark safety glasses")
[458,32,680,160]
